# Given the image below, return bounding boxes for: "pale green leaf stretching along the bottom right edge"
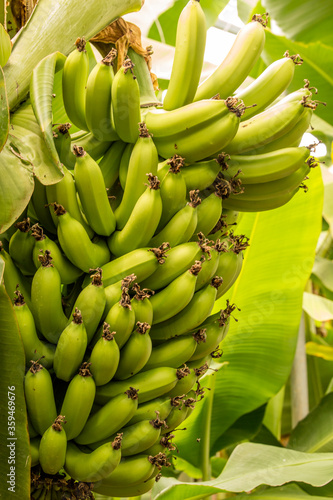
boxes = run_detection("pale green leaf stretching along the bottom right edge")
[153,443,333,500]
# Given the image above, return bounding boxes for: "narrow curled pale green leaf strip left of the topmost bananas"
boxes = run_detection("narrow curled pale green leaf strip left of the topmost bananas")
[30,52,66,168]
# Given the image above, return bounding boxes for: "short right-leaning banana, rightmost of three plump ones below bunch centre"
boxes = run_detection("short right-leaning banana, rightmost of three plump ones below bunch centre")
[113,321,152,382]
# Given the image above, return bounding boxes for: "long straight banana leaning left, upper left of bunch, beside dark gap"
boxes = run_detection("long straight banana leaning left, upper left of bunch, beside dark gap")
[74,146,116,236]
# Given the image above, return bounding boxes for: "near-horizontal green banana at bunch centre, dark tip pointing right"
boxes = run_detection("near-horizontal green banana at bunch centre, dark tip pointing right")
[94,243,169,287]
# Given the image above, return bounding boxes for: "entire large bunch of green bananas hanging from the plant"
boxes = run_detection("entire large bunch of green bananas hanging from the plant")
[0,0,318,499]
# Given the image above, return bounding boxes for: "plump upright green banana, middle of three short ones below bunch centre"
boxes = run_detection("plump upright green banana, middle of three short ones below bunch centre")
[89,322,120,386]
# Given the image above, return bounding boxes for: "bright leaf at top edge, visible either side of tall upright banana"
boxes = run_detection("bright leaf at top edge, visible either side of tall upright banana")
[148,0,228,45]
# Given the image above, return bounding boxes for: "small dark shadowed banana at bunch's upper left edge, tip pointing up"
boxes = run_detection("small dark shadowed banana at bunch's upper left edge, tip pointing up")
[9,217,36,275]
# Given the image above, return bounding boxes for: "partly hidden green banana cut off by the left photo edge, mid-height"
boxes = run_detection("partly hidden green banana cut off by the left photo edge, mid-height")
[0,241,31,309]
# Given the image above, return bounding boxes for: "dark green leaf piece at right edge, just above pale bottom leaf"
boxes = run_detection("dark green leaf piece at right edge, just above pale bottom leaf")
[288,392,333,453]
